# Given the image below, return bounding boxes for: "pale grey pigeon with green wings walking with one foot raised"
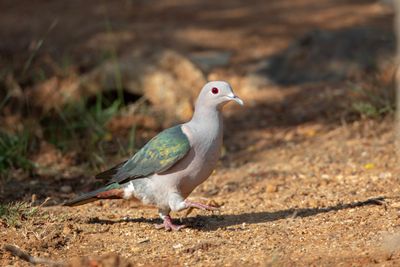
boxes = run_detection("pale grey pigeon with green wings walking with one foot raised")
[64,81,243,230]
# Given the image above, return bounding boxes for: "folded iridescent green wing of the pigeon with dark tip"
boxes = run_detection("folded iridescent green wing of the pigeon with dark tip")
[96,125,190,184]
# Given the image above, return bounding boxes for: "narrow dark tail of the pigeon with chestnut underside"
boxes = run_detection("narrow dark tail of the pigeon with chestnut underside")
[63,183,124,207]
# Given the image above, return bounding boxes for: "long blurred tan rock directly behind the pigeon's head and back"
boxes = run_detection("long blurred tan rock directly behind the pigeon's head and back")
[28,50,206,120]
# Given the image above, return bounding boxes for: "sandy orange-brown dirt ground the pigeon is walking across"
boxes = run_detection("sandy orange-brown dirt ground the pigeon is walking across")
[0,0,400,266]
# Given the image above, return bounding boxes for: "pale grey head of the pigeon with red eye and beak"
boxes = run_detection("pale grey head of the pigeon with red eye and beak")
[196,81,243,108]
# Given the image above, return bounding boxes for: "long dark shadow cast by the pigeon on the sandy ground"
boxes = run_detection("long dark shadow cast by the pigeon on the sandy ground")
[87,197,385,231]
